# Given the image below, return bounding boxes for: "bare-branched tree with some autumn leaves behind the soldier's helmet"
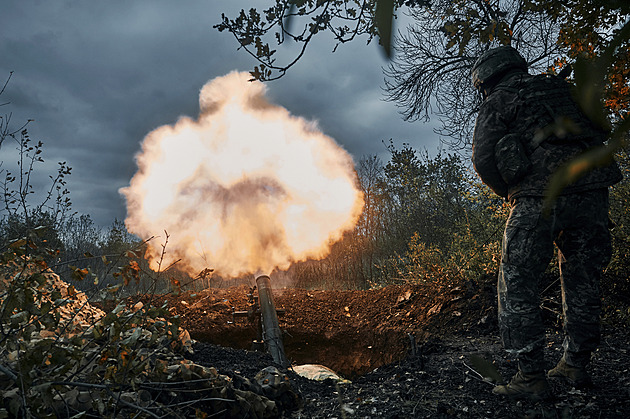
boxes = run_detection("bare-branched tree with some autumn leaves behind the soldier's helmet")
[386,0,630,147]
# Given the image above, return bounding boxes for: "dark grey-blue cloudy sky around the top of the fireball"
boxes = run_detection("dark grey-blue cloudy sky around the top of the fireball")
[0,0,438,226]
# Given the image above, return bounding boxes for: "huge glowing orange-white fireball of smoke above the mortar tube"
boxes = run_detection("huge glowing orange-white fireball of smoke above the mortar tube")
[120,72,363,277]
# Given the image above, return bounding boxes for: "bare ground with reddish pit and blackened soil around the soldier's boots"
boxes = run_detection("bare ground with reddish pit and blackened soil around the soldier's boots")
[157,279,630,418]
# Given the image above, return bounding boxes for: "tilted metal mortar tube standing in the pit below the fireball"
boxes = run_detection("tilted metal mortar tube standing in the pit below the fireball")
[256,275,289,368]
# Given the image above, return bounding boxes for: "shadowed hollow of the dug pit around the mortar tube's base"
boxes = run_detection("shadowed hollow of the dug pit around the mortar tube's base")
[191,326,408,379]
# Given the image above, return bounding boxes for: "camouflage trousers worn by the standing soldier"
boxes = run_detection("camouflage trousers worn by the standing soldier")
[497,189,611,372]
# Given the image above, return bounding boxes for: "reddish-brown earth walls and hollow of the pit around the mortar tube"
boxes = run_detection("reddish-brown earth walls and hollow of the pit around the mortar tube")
[153,285,492,379]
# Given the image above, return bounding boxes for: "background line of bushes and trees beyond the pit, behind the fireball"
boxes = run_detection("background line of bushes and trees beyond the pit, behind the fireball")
[0,120,630,292]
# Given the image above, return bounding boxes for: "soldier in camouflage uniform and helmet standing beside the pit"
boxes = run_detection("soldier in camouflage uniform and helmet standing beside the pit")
[472,46,621,400]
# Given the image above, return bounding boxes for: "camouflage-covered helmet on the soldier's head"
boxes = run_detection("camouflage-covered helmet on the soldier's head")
[472,45,527,89]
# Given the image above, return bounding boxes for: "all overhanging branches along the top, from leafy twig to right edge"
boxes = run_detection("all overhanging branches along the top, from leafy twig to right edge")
[215,0,630,147]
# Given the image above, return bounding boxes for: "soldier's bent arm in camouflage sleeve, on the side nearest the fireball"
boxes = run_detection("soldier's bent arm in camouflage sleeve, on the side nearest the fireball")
[472,98,509,198]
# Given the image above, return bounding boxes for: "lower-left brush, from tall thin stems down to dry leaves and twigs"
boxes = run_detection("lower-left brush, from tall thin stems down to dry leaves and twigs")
[0,90,277,417]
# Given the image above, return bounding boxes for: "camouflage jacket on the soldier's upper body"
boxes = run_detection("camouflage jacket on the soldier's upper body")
[472,72,621,200]
